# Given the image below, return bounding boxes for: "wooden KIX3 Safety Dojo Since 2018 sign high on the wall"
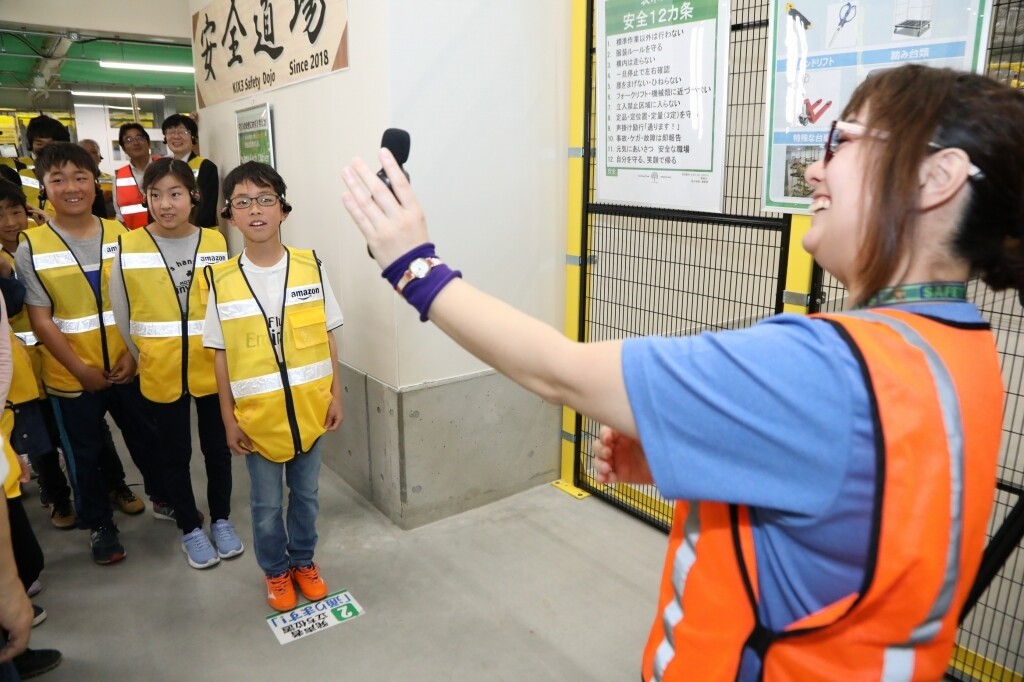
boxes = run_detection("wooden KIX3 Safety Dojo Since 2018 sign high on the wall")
[193,0,348,108]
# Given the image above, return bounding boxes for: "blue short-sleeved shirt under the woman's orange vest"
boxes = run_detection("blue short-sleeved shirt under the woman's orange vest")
[623,302,985,634]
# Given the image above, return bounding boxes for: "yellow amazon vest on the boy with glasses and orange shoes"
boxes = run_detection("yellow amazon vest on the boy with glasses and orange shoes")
[206,248,334,462]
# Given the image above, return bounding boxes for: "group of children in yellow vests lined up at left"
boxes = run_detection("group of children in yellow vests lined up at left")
[0,142,342,626]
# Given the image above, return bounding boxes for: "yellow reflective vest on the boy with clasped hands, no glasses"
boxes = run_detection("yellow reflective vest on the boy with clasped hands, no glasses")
[22,218,128,393]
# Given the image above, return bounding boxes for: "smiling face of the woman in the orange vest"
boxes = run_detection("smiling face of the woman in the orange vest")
[803,111,873,290]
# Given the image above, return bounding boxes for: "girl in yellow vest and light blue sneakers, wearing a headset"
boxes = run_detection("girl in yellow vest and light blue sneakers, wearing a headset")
[111,159,245,568]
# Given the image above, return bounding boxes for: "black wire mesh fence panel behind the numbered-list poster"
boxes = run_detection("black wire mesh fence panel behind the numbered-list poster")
[575,0,788,529]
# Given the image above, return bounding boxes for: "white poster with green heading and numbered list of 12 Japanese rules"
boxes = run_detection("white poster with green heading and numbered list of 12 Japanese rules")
[595,0,729,212]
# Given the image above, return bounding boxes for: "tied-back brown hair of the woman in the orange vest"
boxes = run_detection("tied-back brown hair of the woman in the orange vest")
[843,65,1024,302]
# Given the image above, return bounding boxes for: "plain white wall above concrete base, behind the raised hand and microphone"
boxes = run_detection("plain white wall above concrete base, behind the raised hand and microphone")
[189,0,570,387]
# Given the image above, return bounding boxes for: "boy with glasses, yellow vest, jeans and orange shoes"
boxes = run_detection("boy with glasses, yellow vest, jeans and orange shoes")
[203,162,342,611]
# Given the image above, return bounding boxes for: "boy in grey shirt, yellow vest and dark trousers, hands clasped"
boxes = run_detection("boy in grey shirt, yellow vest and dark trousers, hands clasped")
[14,142,159,564]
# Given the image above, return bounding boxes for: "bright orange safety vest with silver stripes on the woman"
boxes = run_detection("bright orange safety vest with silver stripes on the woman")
[643,308,1004,682]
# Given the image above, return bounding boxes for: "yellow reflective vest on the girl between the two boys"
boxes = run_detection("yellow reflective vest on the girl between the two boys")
[120,228,227,402]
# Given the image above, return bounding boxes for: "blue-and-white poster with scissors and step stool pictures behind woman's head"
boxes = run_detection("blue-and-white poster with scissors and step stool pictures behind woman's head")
[764,0,991,213]
